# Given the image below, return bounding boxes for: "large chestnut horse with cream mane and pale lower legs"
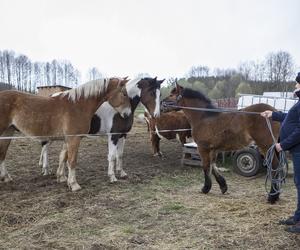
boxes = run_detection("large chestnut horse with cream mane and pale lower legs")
[0,78,131,191]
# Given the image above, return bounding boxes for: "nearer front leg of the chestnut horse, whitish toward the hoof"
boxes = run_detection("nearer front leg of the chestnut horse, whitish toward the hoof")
[67,137,81,191]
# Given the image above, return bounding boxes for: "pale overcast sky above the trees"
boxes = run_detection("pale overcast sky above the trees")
[0,0,300,78]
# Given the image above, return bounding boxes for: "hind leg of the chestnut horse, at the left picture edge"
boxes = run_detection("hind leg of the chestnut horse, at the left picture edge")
[0,127,15,182]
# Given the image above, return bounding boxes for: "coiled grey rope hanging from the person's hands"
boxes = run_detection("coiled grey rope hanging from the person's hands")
[264,117,288,196]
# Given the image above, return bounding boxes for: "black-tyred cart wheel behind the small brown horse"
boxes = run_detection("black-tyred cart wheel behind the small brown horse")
[233,148,262,177]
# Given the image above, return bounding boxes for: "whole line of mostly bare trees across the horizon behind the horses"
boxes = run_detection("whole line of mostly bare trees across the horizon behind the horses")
[0,50,295,99]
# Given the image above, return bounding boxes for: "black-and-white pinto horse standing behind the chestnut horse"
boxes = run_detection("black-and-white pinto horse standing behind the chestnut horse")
[40,78,164,183]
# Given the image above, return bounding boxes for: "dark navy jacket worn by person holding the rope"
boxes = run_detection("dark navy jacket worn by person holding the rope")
[272,101,300,153]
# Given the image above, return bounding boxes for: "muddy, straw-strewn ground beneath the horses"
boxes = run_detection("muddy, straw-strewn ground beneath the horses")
[0,120,300,250]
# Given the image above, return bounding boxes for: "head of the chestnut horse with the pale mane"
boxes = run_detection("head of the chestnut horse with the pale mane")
[107,77,131,118]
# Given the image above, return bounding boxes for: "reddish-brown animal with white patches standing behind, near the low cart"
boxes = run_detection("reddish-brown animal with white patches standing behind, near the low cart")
[144,111,191,157]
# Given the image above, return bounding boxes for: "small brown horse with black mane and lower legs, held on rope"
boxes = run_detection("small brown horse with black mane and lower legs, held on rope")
[164,84,280,203]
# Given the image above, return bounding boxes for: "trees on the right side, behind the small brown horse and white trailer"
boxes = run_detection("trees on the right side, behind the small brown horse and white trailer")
[162,51,296,99]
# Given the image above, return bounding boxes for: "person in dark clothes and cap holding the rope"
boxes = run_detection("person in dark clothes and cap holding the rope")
[261,72,300,233]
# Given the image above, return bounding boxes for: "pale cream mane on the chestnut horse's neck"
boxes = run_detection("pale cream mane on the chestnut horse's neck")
[57,78,109,102]
